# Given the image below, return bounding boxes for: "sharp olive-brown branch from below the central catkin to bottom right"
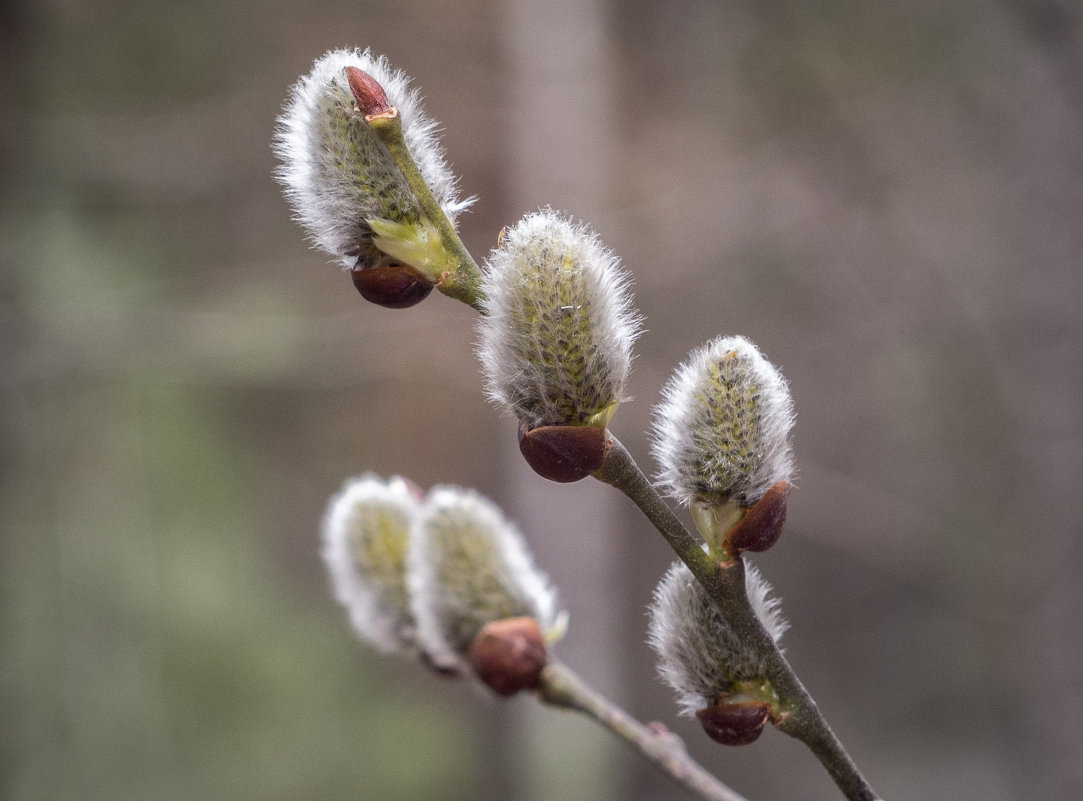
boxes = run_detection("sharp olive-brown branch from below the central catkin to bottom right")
[593,433,877,801]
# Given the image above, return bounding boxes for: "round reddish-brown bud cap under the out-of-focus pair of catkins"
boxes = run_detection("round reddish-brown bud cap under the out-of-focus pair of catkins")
[468,617,549,695]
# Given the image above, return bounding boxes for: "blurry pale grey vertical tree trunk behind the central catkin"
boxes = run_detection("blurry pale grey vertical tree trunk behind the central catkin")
[500,0,642,801]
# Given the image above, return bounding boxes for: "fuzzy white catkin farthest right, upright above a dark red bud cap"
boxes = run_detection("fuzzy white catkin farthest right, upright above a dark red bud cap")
[651,337,794,505]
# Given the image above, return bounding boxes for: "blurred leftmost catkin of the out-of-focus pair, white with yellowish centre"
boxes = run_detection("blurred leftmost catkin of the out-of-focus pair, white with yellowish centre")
[321,475,420,653]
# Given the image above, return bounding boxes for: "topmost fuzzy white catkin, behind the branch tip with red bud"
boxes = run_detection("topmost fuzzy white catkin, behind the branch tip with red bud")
[274,49,471,268]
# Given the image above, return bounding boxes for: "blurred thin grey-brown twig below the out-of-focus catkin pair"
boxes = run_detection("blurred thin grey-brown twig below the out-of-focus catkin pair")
[538,661,746,801]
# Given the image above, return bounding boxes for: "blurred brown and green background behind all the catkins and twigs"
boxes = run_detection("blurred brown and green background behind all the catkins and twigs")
[0,0,1083,801]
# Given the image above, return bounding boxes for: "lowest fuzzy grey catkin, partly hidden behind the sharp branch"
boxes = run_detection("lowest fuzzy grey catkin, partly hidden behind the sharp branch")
[648,562,786,715]
